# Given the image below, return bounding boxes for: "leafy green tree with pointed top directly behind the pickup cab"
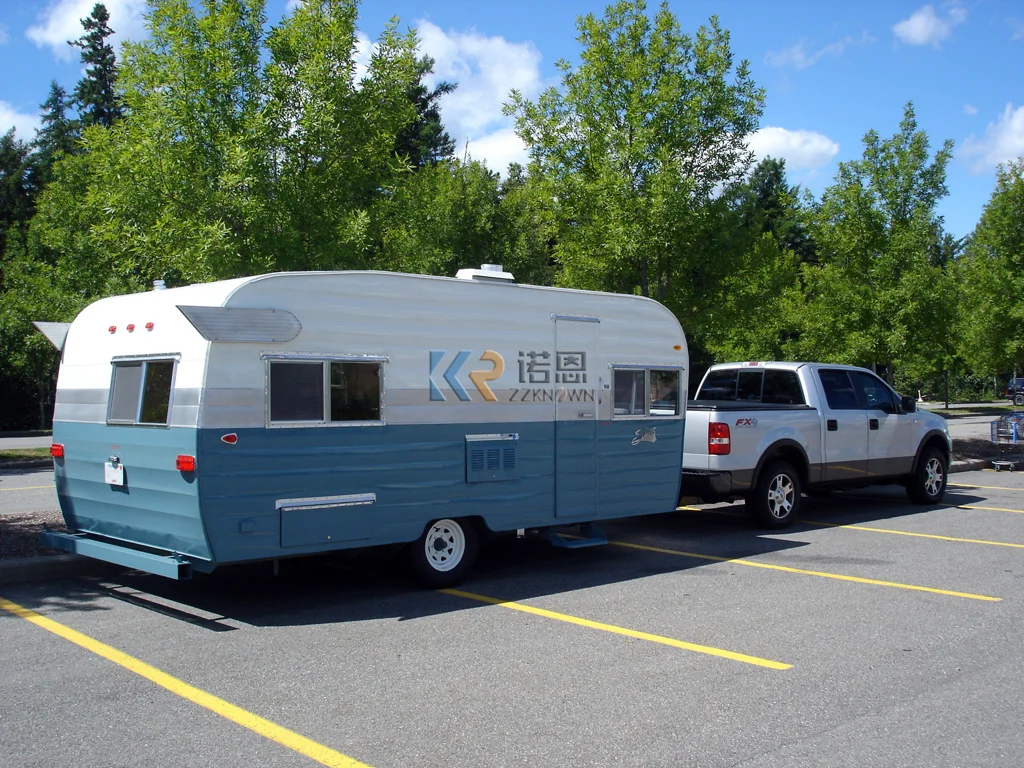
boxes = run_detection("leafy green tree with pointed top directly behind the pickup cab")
[791,103,955,382]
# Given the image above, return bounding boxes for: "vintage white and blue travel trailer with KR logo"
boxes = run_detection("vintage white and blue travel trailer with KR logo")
[37,265,687,586]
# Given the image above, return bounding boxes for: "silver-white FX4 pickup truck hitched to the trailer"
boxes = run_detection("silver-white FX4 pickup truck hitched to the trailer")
[681,362,952,527]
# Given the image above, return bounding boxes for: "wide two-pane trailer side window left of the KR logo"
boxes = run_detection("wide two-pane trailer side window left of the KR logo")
[269,360,382,424]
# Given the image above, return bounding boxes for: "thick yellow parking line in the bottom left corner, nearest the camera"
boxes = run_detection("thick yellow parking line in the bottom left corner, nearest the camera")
[0,597,370,768]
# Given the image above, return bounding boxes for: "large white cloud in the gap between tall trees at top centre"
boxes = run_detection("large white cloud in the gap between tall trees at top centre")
[417,22,544,173]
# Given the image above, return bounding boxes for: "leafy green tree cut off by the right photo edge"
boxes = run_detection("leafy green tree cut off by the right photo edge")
[955,158,1024,375]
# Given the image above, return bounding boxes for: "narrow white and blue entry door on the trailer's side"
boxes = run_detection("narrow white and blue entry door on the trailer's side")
[553,314,601,519]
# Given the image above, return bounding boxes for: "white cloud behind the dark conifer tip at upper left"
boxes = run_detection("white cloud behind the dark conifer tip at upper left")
[25,0,146,60]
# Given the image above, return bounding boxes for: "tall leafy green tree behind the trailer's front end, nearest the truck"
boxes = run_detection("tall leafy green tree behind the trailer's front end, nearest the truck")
[505,0,764,332]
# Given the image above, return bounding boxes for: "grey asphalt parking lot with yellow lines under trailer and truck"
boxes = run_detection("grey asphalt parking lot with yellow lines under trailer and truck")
[0,471,1024,768]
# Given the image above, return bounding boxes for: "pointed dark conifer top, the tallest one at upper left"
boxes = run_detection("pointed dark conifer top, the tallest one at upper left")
[68,3,121,128]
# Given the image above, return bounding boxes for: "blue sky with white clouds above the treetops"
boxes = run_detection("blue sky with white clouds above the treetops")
[0,0,1024,237]
